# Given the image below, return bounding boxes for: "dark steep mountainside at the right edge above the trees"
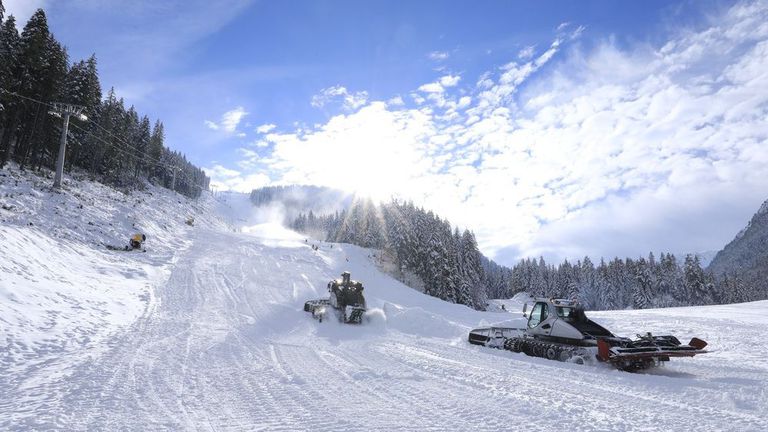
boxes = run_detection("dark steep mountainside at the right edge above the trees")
[707,201,768,298]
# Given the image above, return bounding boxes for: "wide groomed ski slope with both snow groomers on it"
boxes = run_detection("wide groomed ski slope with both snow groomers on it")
[0,179,768,431]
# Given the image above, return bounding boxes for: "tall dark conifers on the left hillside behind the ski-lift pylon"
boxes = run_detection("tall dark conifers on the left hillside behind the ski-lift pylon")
[0,5,210,197]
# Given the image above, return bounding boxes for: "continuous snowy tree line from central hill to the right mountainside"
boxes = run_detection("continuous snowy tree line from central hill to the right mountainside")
[290,193,762,310]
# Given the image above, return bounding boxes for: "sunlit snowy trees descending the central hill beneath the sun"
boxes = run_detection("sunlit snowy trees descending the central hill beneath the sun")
[290,199,487,310]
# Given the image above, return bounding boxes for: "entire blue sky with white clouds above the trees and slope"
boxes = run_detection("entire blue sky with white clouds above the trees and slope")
[4,0,768,264]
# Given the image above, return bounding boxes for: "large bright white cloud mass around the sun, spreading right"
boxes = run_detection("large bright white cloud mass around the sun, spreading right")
[220,2,768,263]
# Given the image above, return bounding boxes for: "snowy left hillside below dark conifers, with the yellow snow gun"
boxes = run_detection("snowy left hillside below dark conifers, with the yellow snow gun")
[0,164,224,398]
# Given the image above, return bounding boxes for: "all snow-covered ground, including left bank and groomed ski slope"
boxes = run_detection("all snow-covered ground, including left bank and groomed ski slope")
[0,166,768,431]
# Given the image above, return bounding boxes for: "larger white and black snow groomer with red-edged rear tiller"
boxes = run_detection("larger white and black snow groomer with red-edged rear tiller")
[469,298,707,371]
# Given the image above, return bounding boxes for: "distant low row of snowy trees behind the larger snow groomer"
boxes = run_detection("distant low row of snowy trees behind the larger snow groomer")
[485,253,748,310]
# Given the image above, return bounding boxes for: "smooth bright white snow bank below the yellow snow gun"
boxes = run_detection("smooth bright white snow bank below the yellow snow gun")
[0,226,154,370]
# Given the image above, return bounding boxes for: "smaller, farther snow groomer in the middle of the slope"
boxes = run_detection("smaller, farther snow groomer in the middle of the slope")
[304,271,366,324]
